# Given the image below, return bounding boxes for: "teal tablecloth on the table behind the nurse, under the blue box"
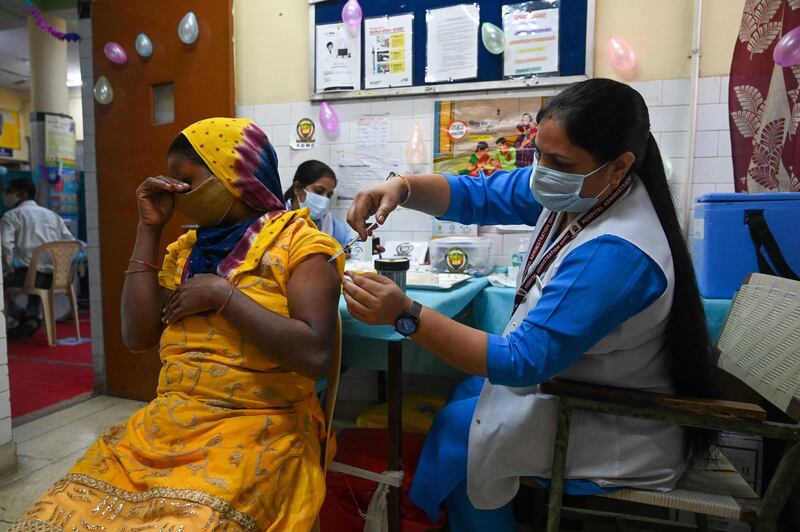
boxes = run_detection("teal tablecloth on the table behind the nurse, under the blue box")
[472,286,731,344]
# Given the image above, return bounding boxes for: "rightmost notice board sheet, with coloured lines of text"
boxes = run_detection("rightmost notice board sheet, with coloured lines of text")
[503,1,559,77]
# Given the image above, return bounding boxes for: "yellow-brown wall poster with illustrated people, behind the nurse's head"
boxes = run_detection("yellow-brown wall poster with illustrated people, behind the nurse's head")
[433,96,547,177]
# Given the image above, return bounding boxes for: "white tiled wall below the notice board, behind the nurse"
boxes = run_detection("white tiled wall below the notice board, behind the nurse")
[237,77,733,265]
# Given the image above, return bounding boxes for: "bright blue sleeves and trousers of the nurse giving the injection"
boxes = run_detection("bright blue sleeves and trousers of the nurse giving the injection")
[410,167,667,532]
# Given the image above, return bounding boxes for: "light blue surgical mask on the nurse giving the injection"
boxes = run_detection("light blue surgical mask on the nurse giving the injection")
[530,163,611,212]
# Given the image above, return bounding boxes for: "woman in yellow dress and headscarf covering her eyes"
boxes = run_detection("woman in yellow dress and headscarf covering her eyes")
[12,118,343,532]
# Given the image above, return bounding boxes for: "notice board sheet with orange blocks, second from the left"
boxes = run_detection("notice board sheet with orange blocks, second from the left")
[364,15,414,89]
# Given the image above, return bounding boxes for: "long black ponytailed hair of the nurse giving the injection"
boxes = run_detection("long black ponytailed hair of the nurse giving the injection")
[536,79,717,459]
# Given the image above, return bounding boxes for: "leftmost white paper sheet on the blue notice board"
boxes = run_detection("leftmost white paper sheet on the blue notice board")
[315,23,361,92]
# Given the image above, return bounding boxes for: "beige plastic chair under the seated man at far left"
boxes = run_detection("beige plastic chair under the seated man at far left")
[6,240,81,346]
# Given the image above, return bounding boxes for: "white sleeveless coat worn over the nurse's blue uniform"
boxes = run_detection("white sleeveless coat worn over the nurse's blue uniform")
[467,178,686,509]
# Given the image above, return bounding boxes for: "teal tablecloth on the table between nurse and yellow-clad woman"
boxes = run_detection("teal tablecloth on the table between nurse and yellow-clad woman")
[339,277,489,377]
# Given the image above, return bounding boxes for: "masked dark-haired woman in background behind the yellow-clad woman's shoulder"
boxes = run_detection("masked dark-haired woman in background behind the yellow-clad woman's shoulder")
[283,160,350,245]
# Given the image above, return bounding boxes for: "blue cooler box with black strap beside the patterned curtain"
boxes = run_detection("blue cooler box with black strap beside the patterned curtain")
[689,192,800,299]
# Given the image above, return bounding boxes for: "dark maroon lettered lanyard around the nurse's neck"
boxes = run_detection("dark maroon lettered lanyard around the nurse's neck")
[512,175,633,315]
